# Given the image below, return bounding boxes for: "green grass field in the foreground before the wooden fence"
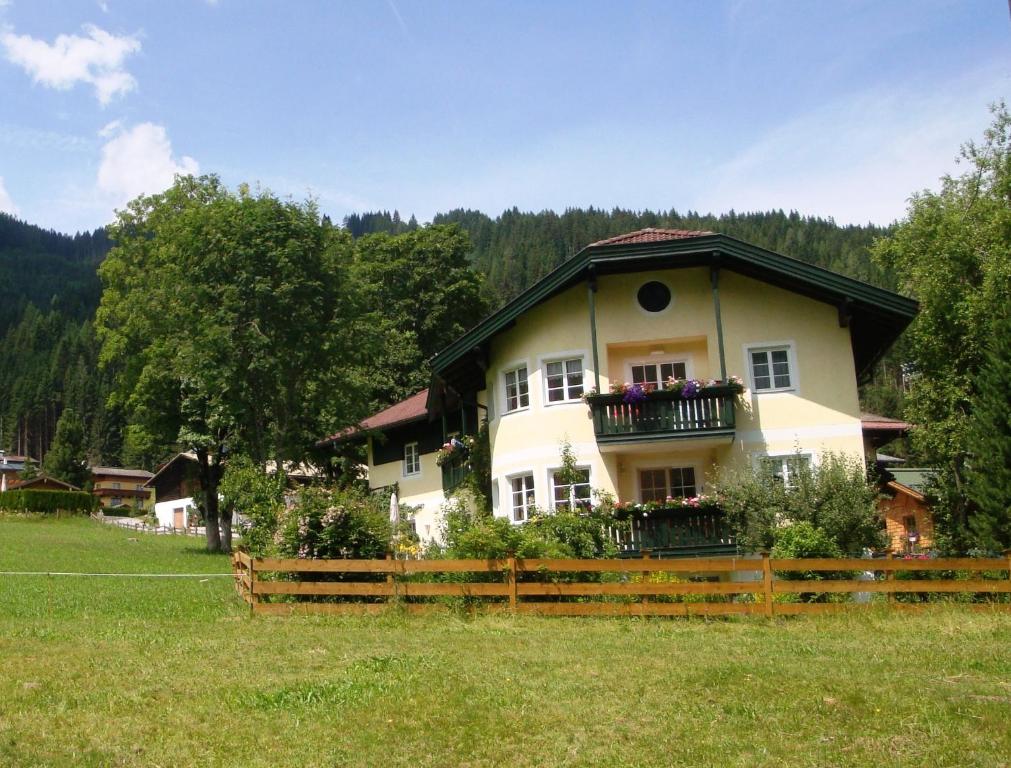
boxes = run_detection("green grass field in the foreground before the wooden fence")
[0,519,1011,768]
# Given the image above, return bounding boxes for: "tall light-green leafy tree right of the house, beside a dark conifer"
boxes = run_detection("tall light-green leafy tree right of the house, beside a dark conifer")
[875,104,1011,551]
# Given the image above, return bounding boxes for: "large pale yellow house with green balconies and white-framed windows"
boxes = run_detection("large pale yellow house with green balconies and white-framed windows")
[330,229,917,551]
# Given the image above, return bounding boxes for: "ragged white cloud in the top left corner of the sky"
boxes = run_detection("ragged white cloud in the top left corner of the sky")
[0,24,141,106]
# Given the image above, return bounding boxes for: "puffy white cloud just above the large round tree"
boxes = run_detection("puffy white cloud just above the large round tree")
[98,120,200,206]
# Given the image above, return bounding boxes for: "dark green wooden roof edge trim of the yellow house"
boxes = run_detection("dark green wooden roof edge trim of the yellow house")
[431,233,919,376]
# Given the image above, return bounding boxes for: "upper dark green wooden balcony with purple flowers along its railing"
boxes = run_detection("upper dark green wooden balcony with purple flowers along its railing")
[586,386,739,446]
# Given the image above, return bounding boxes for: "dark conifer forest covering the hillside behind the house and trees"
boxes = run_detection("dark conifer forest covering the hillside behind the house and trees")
[0,208,900,464]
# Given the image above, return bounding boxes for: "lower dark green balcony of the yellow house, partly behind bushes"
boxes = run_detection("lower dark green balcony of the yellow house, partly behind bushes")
[615,508,737,558]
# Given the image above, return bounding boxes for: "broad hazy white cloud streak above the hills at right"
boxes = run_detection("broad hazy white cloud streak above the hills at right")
[693,74,1007,224]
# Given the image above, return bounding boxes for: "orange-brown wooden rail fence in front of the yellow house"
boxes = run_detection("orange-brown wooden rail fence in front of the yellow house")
[233,552,1011,616]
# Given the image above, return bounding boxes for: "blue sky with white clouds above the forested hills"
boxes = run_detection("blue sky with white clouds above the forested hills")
[0,0,1011,231]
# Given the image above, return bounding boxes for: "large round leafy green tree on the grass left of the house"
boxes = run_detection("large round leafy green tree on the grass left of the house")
[96,176,372,551]
